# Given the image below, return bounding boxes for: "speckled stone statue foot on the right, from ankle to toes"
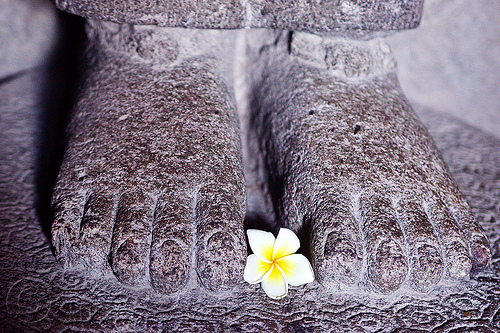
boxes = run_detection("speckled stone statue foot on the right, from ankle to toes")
[248,32,491,293]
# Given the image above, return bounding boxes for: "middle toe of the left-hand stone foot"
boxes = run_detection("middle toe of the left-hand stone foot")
[110,192,153,287]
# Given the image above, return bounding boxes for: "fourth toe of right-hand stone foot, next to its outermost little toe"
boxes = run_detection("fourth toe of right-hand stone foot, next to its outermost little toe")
[427,200,472,280]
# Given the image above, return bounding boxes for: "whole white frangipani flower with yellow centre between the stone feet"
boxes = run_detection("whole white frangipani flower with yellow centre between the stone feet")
[244,228,314,299]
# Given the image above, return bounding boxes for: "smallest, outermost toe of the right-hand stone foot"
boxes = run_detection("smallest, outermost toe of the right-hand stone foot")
[451,198,491,271]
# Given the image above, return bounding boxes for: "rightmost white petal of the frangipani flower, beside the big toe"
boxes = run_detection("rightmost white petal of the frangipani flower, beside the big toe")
[276,254,314,286]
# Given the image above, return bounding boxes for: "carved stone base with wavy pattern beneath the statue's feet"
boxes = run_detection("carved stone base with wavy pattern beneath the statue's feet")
[0,67,500,332]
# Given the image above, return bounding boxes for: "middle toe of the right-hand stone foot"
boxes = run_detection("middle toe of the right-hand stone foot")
[400,202,444,292]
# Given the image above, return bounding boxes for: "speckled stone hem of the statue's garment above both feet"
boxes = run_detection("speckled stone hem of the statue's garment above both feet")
[56,0,423,33]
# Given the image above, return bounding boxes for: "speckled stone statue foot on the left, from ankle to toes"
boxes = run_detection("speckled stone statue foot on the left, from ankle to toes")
[52,21,247,294]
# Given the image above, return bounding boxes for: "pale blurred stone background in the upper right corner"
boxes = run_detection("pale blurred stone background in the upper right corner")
[388,0,500,138]
